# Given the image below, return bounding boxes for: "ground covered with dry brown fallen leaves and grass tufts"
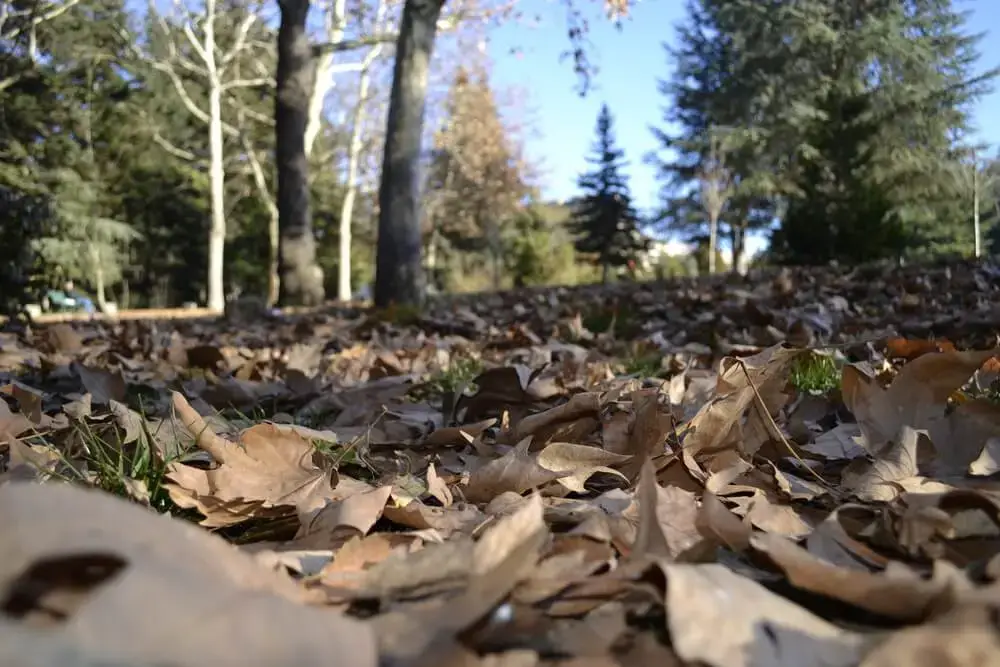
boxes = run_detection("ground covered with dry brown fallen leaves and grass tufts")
[0,264,1000,667]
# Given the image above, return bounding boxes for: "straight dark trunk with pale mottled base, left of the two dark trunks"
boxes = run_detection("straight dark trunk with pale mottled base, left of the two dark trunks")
[274,0,325,306]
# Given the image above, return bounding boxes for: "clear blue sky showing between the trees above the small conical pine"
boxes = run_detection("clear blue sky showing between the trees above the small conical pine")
[489,0,1000,245]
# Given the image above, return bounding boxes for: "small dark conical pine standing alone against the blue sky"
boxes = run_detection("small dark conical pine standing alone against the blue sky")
[570,104,649,283]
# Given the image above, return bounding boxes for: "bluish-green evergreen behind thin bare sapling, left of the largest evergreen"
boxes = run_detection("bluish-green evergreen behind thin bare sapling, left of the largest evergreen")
[650,0,778,270]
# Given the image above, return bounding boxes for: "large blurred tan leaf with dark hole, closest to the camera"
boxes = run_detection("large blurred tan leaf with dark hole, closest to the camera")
[0,483,377,667]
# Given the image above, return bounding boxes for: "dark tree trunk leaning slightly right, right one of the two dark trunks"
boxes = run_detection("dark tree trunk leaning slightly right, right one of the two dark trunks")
[375,0,445,306]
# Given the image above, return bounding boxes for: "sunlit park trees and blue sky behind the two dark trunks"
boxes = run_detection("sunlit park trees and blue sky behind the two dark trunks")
[0,0,1000,308]
